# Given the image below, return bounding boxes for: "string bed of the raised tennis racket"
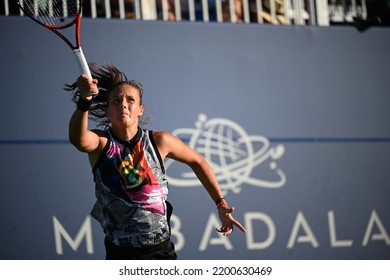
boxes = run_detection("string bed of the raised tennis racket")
[22,0,81,26]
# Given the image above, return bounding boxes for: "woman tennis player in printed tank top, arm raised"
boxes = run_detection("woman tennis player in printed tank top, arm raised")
[65,64,246,259]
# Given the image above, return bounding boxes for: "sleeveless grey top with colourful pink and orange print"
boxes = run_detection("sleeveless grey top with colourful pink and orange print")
[91,128,169,247]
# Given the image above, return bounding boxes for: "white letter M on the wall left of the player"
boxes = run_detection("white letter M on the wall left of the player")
[53,216,93,255]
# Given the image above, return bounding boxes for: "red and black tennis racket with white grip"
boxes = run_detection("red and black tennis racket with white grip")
[18,0,92,78]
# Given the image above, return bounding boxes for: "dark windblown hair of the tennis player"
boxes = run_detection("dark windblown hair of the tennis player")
[64,63,143,128]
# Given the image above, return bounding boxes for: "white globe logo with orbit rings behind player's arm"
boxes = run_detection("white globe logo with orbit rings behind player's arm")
[166,114,286,194]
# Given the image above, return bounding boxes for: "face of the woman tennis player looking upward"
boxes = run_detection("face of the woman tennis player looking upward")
[107,84,144,127]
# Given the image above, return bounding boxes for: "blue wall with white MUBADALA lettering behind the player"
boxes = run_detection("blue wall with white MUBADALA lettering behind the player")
[0,17,390,259]
